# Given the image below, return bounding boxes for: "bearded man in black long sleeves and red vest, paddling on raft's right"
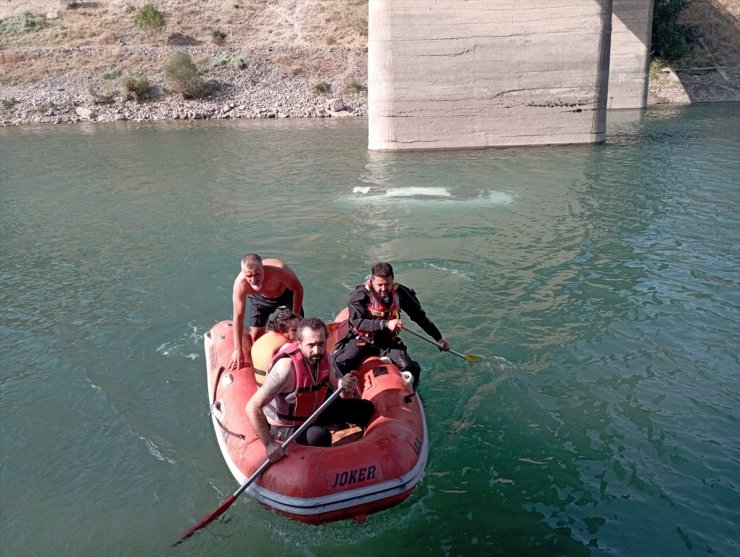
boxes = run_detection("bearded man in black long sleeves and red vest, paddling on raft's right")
[334,263,450,389]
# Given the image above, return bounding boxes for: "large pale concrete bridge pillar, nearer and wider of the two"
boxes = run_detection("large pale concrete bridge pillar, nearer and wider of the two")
[368,0,652,150]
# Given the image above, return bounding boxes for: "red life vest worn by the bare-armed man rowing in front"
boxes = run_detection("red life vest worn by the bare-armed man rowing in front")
[265,342,331,427]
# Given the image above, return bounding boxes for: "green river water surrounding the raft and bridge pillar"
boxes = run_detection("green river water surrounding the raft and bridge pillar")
[0,105,740,557]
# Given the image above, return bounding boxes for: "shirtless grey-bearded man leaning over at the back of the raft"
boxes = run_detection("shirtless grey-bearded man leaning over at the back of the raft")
[229,253,303,369]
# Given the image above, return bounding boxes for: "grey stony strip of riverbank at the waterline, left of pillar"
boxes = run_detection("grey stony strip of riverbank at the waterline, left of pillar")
[0,47,367,126]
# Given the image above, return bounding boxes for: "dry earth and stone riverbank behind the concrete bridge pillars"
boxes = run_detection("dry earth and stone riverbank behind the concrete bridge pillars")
[0,0,740,125]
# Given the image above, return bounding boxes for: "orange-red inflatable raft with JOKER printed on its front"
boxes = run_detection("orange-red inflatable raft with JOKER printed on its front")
[205,314,429,524]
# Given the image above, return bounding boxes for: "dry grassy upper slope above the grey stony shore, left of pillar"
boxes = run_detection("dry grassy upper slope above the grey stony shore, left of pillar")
[0,0,367,83]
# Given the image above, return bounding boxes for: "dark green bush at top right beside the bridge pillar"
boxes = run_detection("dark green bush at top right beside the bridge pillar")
[652,0,696,61]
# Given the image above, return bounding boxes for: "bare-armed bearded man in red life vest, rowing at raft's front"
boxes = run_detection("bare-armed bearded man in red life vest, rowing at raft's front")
[245,317,375,462]
